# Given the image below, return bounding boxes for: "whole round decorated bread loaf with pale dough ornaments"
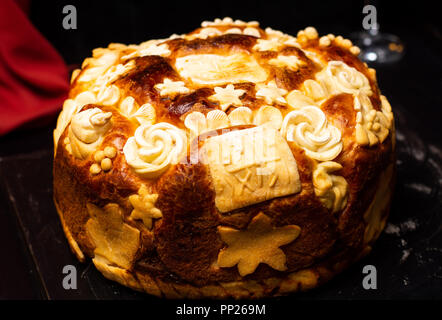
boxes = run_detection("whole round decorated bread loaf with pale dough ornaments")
[54,18,395,298]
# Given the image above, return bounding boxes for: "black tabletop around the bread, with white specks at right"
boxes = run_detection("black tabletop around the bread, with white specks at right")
[0,27,442,303]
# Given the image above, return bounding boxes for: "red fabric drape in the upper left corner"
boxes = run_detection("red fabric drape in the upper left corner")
[0,0,69,135]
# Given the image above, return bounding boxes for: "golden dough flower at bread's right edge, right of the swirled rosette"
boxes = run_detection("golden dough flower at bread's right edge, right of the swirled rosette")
[353,94,393,146]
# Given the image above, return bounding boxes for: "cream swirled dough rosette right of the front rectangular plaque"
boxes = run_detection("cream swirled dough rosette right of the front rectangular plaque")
[281,106,342,161]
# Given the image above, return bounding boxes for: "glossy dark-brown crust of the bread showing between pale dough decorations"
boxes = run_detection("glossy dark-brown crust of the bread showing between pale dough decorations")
[54,21,394,298]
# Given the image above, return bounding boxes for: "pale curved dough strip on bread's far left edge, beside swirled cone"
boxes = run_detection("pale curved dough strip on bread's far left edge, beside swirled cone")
[54,91,96,147]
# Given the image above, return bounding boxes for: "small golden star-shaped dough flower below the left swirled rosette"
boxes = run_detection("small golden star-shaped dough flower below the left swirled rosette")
[129,185,163,230]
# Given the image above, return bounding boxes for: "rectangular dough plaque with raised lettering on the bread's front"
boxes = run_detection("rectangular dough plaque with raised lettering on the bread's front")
[204,125,301,212]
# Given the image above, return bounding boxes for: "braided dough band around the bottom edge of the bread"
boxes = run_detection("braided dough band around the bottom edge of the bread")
[57,165,394,299]
